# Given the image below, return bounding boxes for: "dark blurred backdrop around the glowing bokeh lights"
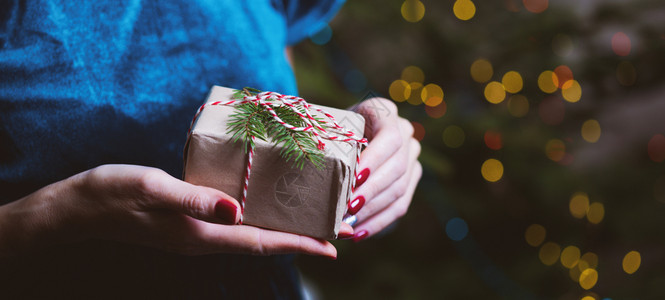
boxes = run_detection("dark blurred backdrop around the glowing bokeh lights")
[294,0,665,299]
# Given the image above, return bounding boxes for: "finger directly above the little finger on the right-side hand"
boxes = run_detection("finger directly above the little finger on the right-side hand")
[354,139,420,220]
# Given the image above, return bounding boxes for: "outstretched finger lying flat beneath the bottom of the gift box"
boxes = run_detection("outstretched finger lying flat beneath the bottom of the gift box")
[202,223,337,259]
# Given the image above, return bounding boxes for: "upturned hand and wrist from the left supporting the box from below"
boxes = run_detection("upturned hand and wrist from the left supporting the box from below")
[0,165,340,258]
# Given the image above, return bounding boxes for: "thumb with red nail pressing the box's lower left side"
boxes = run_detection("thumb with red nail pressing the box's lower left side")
[141,170,240,224]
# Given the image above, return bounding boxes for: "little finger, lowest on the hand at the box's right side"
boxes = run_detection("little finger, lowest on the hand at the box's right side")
[353,164,422,242]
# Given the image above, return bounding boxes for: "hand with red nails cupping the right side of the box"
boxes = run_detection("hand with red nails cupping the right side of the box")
[349,98,422,242]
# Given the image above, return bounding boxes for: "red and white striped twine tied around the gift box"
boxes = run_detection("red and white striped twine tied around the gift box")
[188,92,367,224]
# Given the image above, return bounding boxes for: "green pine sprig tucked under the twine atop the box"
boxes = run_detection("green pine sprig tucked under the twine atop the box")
[227,88,324,170]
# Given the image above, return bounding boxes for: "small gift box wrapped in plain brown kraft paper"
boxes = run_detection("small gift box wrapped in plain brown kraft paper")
[184,86,365,239]
